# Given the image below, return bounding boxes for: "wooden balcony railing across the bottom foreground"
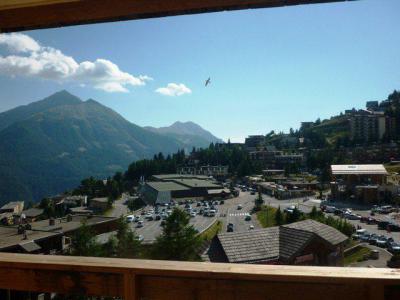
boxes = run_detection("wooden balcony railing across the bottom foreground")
[0,253,400,300]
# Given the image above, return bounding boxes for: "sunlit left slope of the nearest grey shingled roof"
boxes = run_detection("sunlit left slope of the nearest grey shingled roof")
[218,227,279,263]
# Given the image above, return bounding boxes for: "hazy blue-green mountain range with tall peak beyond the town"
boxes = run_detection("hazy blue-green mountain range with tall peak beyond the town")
[0,91,222,204]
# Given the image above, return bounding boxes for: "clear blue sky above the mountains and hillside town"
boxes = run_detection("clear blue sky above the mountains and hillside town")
[0,0,400,141]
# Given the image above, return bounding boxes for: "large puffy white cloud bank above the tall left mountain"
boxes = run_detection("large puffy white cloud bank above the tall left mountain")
[0,34,153,92]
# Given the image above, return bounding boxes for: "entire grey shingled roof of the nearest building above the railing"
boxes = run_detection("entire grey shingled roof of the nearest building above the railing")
[217,220,348,263]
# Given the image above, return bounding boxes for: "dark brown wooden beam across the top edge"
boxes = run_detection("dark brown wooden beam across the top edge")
[0,0,351,32]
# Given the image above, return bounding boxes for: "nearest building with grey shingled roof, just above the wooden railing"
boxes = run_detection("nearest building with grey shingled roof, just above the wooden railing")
[206,220,348,266]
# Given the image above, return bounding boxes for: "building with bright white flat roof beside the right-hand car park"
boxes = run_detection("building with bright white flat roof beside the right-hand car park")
[331,164,397,203]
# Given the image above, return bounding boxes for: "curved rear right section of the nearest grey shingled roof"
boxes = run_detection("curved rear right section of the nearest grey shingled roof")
[283,220,348,246]
